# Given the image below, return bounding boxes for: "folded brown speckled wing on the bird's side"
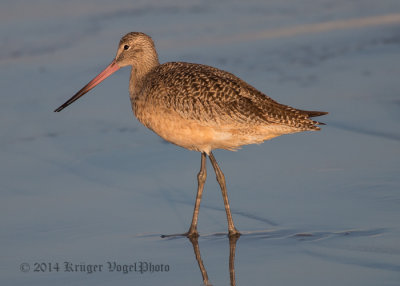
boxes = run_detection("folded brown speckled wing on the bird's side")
[150,62,315,129]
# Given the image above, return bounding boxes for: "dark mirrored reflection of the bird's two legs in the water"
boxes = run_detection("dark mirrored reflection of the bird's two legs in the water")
[188,236,240,286]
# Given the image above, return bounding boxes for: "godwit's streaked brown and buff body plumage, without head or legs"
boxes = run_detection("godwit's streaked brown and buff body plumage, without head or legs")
[132,62,325,153]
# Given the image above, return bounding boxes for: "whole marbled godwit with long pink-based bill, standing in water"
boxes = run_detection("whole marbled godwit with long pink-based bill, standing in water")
[55,32,327,237]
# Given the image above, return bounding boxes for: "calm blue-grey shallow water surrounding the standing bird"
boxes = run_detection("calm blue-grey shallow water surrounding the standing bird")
[0,0,400,285]
